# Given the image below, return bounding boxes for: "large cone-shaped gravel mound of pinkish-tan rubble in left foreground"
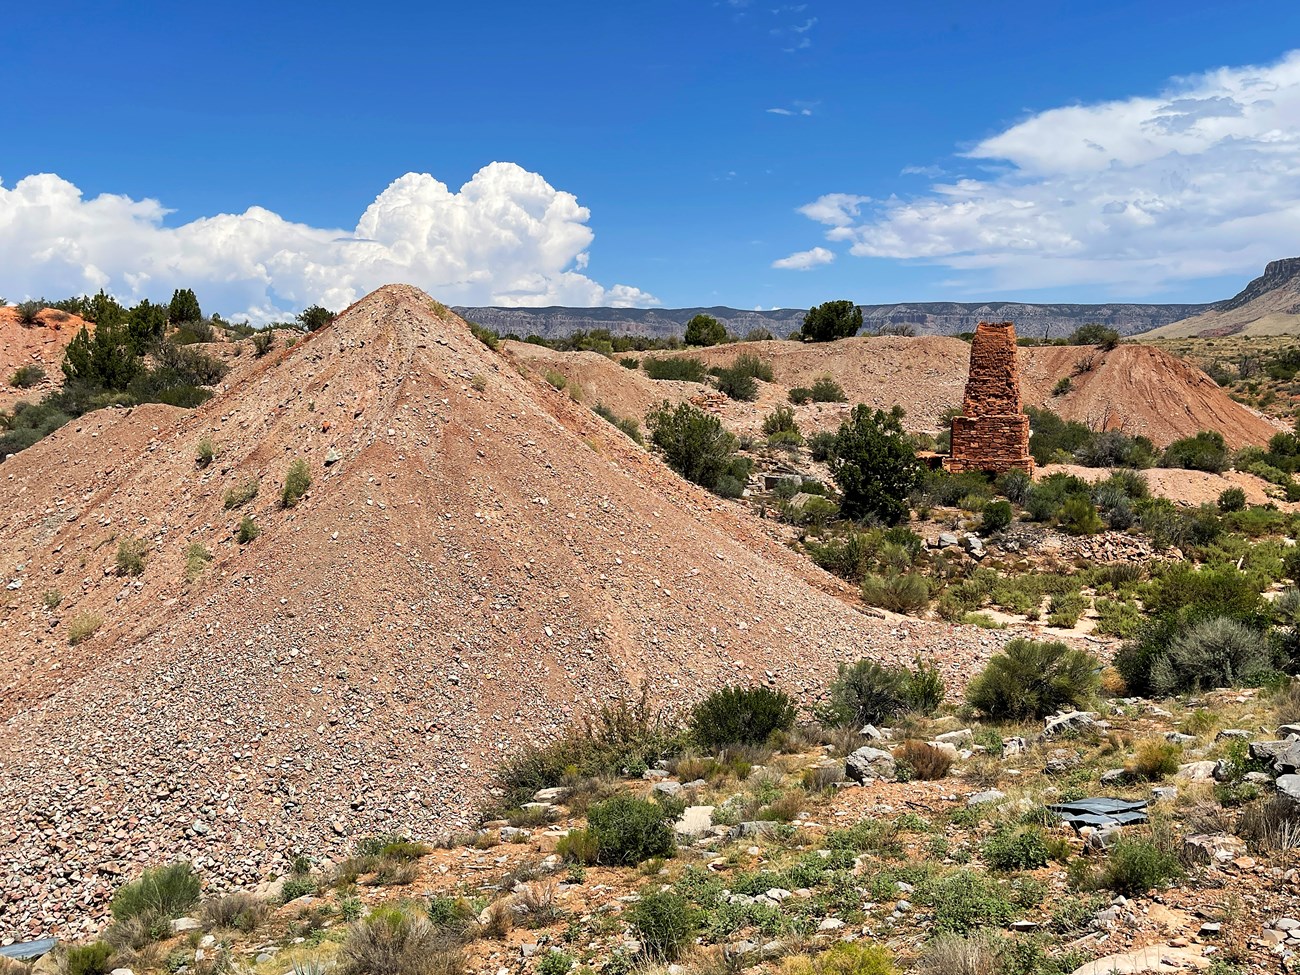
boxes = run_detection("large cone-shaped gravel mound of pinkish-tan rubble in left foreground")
[0,286,996,936]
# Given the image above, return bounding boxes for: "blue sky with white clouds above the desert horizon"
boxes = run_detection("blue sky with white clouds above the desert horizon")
[0,0,1300,317]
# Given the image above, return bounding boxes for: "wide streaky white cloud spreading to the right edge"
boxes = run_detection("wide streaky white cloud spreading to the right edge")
[802,51,1300,295]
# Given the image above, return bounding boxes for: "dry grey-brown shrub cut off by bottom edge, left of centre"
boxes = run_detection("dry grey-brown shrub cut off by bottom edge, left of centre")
[338,906,464,975]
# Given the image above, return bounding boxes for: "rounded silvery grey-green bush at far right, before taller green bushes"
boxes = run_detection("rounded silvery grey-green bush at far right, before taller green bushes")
[1151,616,1273,694]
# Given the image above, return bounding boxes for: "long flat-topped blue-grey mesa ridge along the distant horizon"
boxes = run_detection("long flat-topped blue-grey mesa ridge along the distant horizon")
[455,302,1214,338]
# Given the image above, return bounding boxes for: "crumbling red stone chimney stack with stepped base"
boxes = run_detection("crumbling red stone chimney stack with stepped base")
[944,321,1034,473]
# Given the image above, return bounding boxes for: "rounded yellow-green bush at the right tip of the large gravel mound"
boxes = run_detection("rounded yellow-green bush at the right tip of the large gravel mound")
[966,638,1101,720]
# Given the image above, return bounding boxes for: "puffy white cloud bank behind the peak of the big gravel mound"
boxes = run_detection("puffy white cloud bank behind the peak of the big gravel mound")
[0,163,658,320]
